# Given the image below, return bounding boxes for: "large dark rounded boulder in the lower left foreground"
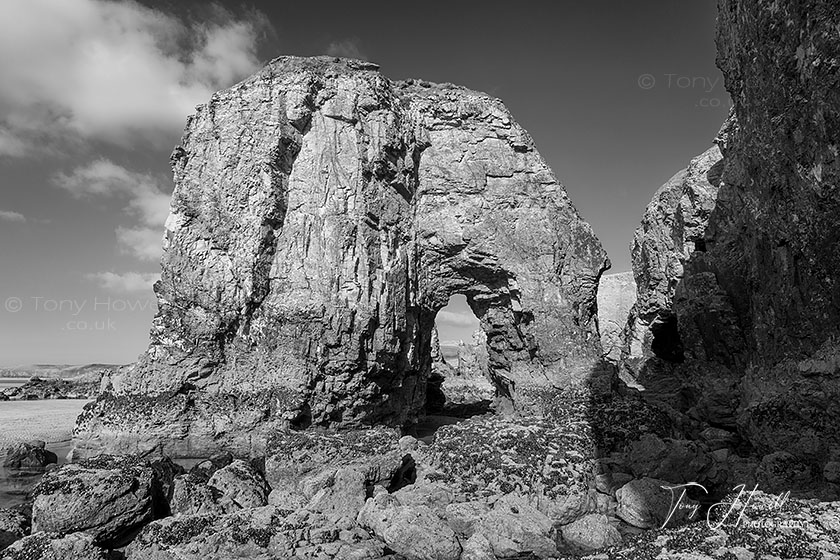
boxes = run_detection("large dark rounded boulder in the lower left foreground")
[32,455,176,547]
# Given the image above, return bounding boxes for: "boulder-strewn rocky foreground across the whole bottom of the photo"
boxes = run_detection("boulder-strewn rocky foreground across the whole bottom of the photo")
[0,393,840,560]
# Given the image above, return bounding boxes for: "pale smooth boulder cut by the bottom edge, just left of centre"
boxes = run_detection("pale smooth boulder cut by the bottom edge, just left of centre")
[357,493,461,560]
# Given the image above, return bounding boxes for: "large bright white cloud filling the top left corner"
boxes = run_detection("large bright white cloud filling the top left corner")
[0,0,268,156]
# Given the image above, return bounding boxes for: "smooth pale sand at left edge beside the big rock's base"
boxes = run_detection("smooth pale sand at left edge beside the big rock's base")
[0,399,90,451]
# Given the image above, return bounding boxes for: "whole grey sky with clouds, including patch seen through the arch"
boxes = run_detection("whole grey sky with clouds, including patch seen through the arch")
[0,0,731,367]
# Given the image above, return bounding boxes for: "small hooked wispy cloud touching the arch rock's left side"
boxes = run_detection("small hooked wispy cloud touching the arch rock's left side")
[53,159,170,261]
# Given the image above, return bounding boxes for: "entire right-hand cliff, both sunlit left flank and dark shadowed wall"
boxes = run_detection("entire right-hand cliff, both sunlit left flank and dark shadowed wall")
[625,0,840,492]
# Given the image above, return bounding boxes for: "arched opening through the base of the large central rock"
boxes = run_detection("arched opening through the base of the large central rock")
[412,294,496,441]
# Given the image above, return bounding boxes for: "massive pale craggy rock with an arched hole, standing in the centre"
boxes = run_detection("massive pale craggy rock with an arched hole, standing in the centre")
[76,57,607,455]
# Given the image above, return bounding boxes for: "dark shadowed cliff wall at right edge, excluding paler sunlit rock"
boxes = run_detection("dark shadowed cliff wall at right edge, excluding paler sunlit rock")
[710,0,840,466]
